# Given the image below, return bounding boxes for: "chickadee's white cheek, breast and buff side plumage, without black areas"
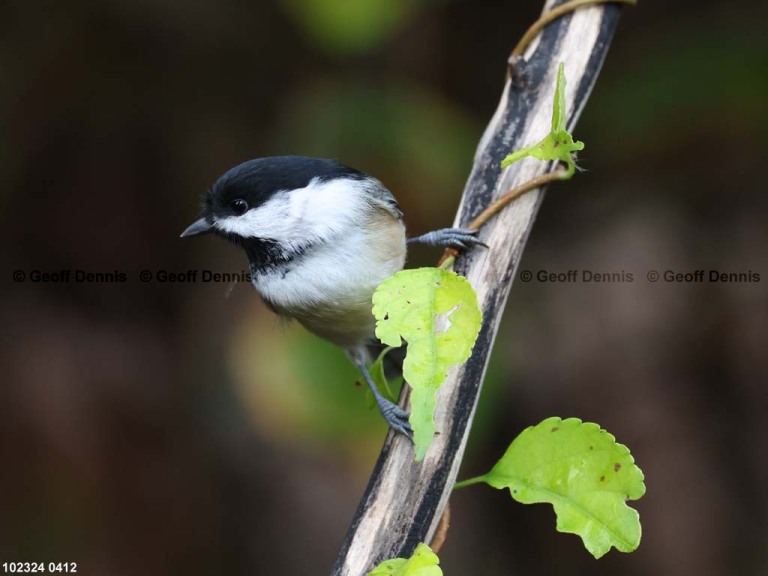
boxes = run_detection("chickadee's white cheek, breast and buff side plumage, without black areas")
[216,180,406,348]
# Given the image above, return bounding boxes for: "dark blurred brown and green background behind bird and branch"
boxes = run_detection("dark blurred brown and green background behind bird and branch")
[0,0,768,576]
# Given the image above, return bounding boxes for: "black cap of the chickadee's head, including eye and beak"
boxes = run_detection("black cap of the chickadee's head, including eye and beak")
[181,156,366,238]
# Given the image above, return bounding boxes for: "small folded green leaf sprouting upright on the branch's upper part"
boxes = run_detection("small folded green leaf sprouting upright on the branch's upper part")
[501,62,584,180]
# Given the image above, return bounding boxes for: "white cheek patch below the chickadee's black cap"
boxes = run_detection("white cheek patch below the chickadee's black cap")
[214,179,368,244]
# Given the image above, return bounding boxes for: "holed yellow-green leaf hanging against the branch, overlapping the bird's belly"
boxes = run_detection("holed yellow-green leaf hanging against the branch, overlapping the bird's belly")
[373,268,482,460]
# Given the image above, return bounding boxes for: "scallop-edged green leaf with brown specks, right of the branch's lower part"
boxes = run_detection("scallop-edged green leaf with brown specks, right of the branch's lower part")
[457,417,645,558]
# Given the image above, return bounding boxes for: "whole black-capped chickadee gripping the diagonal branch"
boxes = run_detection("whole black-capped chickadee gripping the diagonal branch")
[181,156,482,436]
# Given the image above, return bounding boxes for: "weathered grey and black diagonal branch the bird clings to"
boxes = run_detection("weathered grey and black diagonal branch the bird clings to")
[333,0,620,576]
